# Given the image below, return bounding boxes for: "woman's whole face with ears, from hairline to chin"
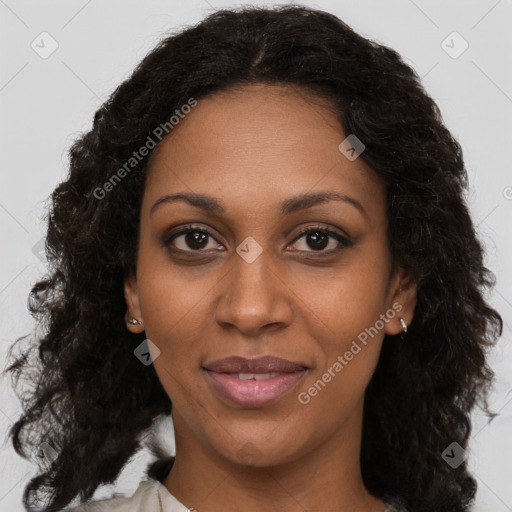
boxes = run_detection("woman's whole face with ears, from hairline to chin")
[125,85,415,466]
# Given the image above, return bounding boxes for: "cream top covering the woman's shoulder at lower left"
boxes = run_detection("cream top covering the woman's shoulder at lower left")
[64,478,189,512]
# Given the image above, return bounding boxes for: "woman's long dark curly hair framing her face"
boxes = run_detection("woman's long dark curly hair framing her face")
[5,6,503,512]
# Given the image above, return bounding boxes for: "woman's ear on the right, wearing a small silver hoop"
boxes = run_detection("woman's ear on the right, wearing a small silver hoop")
[385,268,418,335]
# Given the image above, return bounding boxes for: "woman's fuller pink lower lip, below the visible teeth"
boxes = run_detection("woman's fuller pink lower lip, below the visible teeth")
[206,370,306,408]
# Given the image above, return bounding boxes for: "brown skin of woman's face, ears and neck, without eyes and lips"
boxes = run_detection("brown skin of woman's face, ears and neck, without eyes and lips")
[124,84,416,512]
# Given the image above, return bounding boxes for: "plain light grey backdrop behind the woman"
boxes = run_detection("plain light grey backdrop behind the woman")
[0,0,512,512]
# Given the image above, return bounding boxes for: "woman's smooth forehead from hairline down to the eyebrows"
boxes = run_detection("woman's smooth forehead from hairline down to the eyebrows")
[145,84,384,222]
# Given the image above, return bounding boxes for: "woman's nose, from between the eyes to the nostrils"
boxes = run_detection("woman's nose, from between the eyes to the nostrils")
[214,251,294,336]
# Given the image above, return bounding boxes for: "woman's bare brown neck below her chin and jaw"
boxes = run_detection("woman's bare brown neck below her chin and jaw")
[162,407,384,512]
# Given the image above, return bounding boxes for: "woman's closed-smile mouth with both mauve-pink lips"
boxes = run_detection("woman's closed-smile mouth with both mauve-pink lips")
[203,356,308,408]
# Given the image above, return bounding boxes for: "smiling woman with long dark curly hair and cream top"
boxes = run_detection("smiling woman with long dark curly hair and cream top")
[4,7,502,512]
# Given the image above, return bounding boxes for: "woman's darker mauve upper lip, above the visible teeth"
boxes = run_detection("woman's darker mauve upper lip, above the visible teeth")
[203,356,307,373]
